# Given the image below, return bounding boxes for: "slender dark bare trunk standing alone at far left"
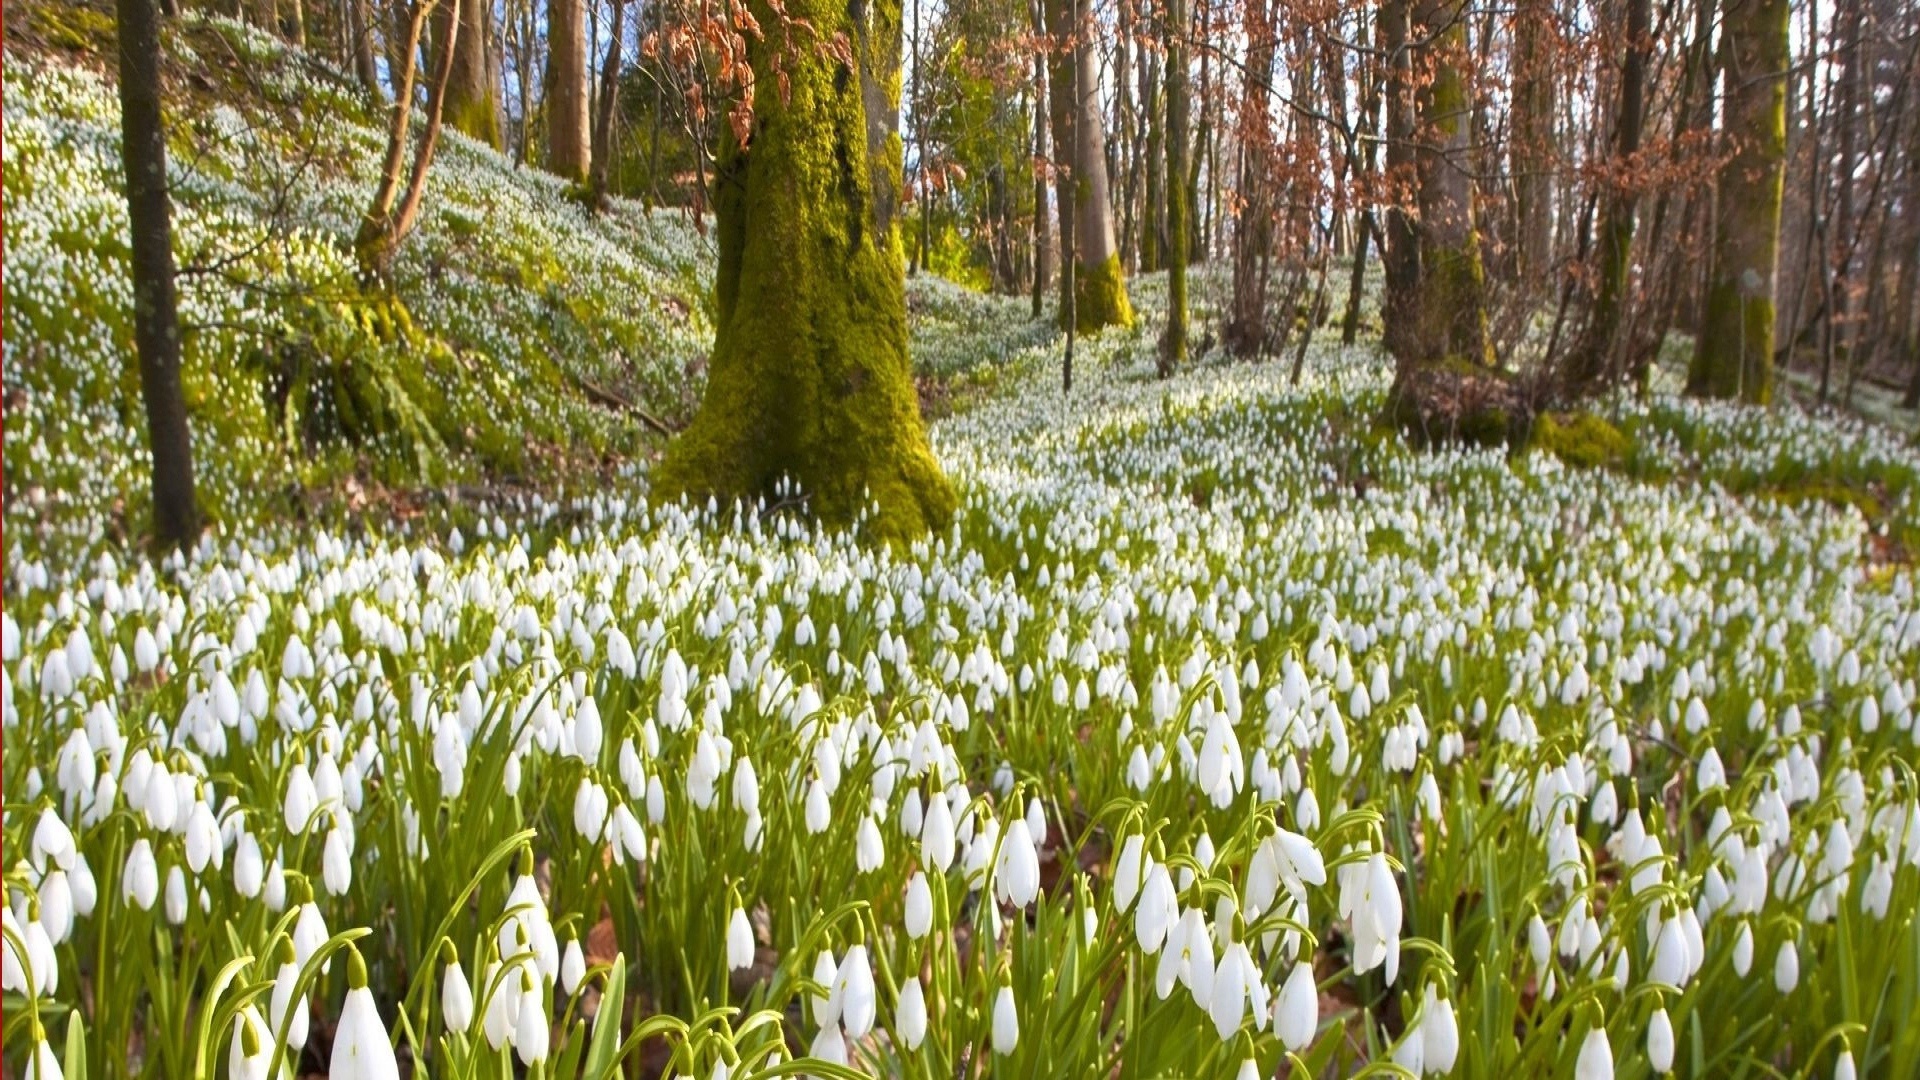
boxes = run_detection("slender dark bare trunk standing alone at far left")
[115,0,200,550]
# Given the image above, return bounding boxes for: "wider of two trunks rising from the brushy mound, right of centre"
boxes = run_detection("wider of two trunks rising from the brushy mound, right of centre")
[1413,0,1494,367]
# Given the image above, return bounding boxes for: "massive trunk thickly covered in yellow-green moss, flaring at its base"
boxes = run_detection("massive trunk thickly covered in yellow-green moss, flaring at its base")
[653,0,954,540]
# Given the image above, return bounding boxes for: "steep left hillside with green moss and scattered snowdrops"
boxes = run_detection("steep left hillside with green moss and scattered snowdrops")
[4,4,712,550]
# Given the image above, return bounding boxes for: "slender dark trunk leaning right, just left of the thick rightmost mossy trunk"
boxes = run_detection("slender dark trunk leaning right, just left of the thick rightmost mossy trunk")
[1565,0,1653,394]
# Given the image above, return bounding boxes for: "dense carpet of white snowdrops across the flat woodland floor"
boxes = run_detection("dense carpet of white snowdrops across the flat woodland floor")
[0,14,1920,1080]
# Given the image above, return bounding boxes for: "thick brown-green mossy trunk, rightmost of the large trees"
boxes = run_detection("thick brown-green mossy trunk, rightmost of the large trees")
[1688,0,1789,404]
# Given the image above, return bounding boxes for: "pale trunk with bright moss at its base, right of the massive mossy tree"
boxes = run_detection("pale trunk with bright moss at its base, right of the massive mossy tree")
[1046,0,1133,332]
